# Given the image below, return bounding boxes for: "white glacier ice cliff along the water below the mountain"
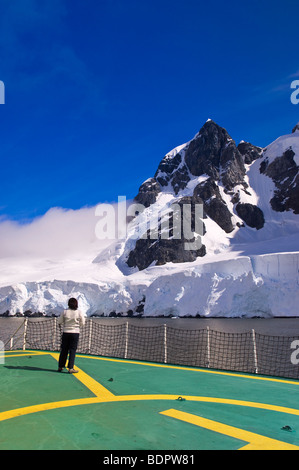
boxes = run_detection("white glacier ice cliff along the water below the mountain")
[0,248,299,318]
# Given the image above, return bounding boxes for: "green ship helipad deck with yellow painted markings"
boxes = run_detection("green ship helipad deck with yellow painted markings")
[0,351,299,451]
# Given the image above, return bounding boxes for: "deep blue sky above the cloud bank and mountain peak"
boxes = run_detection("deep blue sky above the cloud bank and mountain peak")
[0,0,299,222]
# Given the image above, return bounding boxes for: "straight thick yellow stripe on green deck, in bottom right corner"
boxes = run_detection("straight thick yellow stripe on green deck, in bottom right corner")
[160,409,299,450]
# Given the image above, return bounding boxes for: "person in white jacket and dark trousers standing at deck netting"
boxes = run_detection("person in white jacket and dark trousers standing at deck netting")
[58,298,85,374]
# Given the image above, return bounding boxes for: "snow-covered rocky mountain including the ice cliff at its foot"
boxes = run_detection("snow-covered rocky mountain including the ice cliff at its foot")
[0,120,299,317]
